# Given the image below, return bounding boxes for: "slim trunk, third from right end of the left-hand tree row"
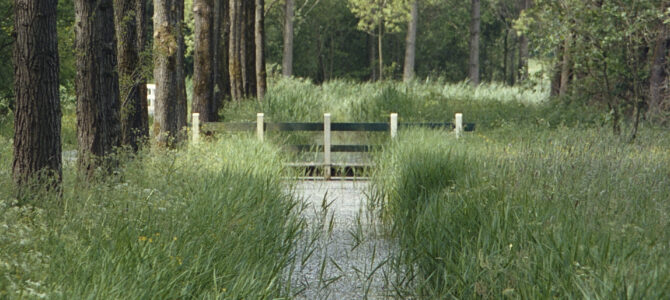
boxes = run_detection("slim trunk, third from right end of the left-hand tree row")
[228,0,244,101]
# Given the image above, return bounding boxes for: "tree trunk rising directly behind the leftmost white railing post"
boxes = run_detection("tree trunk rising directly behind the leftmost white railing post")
[191,0,215,122]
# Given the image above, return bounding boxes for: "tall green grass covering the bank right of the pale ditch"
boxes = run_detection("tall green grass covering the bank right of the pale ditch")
[375,128,670,299]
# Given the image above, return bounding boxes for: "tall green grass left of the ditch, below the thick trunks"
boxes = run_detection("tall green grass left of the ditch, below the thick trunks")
[0,137,304,299]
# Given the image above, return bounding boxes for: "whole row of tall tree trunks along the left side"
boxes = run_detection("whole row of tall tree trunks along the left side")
[12,0,266,190]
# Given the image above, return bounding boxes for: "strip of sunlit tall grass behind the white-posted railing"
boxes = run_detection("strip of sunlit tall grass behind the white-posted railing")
[223,78,604,128]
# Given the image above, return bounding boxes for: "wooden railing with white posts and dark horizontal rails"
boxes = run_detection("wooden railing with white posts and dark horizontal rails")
[191,113,475,179]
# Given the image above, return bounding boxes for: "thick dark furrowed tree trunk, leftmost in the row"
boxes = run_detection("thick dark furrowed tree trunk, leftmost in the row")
[12,0,62,194]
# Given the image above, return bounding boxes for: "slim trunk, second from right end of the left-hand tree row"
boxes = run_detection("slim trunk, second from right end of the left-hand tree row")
[242,0,256,98]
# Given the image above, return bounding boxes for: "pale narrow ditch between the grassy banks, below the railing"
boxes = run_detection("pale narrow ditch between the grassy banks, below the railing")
[291,181,389,299]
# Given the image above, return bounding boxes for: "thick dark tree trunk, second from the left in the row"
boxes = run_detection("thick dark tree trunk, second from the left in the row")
[74,0,121,179]
